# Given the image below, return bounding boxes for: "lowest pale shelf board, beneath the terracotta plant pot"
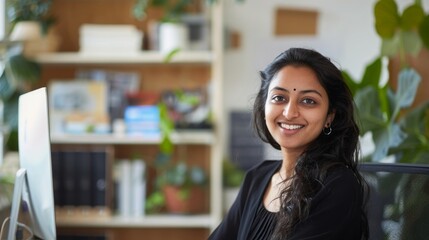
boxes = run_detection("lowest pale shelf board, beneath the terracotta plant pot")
[56,215,213,228]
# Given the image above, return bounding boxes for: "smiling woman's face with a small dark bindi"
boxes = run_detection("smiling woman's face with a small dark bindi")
[265,66,334,153]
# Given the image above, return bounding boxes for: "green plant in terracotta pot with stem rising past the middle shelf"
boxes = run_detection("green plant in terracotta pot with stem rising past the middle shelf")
[146,103,207,214]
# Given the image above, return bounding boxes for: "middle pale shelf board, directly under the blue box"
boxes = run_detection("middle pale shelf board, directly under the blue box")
[51,130,214,145]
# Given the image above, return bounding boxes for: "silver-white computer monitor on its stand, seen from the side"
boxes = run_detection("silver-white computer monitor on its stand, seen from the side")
[8,87,56,240]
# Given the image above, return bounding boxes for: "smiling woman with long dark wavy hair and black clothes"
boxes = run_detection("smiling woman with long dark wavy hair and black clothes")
[209,48,368,240]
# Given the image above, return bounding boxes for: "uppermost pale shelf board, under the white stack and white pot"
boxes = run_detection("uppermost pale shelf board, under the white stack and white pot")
[35,51,213,64]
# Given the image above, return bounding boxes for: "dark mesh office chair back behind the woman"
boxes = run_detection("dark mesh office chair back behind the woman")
[359,163,429,240]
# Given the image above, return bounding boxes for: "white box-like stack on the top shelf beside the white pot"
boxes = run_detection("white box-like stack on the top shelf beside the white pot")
[79,24,143,54]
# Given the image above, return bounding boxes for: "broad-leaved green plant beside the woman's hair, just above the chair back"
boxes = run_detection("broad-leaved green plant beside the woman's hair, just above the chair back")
[343,61,429,163]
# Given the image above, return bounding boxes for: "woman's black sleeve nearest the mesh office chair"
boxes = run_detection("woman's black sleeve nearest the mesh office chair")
[290,169,362,240]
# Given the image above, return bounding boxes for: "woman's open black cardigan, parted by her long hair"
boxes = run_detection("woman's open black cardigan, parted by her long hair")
[209,161,362,240]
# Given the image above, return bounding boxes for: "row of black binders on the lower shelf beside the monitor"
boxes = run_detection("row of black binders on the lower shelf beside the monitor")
[52,147,113,215]
